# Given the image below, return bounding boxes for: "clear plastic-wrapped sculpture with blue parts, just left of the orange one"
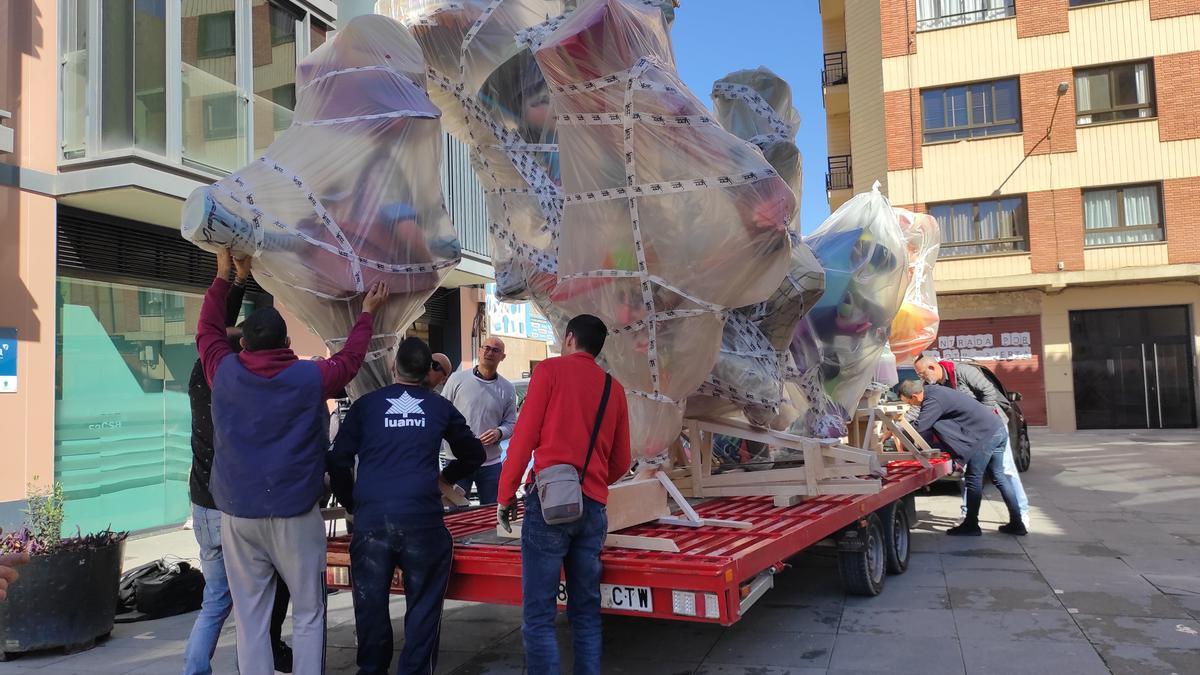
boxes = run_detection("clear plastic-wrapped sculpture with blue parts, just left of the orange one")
[792,184,908,438]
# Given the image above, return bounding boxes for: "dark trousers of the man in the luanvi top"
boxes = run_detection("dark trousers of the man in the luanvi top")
[350,522,454,675]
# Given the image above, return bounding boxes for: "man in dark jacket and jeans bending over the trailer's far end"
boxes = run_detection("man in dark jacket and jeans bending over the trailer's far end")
[900,380,1027,537]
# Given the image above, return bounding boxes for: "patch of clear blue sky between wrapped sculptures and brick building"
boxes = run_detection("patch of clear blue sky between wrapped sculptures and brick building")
[671,0,829,234]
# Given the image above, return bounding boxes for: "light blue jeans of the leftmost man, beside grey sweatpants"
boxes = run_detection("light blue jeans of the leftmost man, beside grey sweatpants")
[184,504,233,675]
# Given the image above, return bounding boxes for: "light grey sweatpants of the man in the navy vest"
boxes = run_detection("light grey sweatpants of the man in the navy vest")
[221,506,325,675]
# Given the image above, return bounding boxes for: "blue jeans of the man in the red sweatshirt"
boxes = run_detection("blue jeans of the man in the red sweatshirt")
[521,490,608,675]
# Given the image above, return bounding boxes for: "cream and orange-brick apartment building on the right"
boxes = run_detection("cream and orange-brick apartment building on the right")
[821,0,1200,430]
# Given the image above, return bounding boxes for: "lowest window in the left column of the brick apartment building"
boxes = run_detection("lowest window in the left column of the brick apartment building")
[929,197,1030,258]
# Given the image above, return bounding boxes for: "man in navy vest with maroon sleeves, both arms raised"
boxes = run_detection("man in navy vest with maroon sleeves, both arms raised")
[196,251,388,675]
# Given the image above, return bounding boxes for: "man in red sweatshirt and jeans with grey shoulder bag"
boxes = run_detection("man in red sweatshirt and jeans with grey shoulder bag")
[498,315,631,675]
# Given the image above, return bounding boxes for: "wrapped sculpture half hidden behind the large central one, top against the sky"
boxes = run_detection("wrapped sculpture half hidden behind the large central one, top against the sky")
[688,67,824,429]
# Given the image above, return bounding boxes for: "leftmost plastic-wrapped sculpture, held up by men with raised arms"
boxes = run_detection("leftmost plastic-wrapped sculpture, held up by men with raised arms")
[182,16,461,396]
